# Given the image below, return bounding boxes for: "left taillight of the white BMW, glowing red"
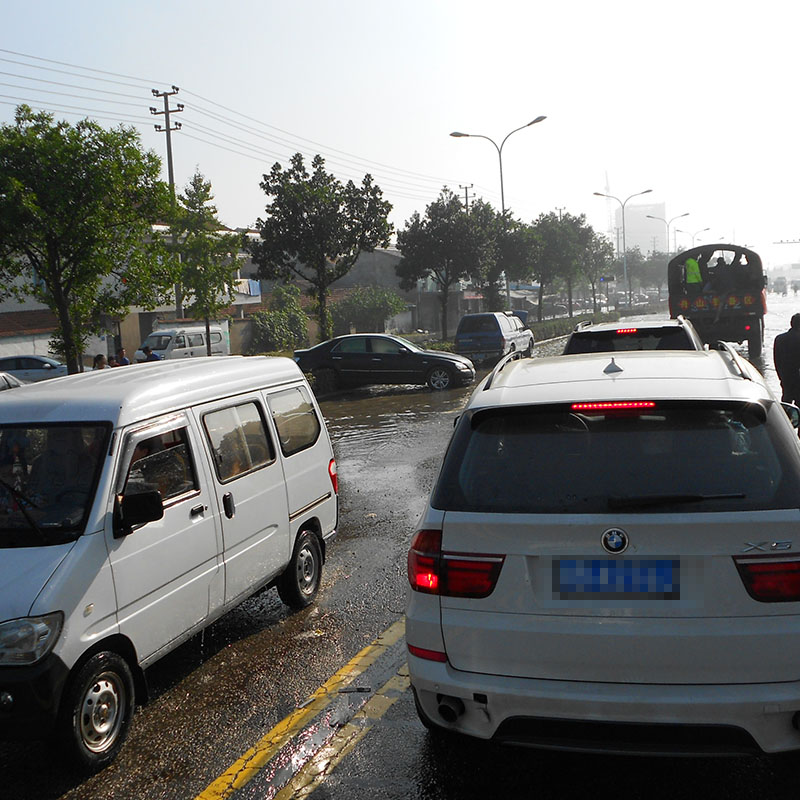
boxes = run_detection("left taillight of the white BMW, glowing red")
[408,530,505,598]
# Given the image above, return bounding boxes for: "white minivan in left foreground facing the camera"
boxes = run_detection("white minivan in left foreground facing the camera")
[0,356,338,769]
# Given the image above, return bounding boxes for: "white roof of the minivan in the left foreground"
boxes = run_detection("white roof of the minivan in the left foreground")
[0,356,302,427]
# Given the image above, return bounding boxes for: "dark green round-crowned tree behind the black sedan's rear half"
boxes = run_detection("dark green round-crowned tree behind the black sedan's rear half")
[250,153,392,339]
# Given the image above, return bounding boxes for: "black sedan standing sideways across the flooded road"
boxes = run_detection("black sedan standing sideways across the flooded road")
[294,333,475,389]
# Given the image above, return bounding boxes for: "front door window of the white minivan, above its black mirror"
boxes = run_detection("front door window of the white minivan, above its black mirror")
[122,428,199,502]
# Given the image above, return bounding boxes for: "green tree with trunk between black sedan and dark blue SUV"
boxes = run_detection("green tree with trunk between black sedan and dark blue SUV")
[395,187,483,341]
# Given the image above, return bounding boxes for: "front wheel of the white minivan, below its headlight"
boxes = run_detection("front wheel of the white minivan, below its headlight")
[57,652,136,772]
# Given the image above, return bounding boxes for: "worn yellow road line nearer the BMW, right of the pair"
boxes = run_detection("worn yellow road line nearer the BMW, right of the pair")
[275,664,410,800]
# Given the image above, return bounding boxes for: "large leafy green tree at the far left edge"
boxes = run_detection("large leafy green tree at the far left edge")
[0,105,174,372]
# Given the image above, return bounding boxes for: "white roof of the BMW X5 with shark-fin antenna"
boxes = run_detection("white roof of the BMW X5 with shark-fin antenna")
[469,350,775,408]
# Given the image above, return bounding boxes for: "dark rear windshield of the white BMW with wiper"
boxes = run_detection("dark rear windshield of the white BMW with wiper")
[432,402,800,514]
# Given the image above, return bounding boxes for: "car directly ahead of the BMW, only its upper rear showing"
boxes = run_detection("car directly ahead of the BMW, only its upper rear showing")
[564,317,704,355]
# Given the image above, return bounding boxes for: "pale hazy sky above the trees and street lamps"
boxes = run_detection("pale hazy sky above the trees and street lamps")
[0,0,800,268]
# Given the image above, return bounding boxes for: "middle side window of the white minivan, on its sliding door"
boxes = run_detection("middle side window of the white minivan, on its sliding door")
[203,402,275,483]
